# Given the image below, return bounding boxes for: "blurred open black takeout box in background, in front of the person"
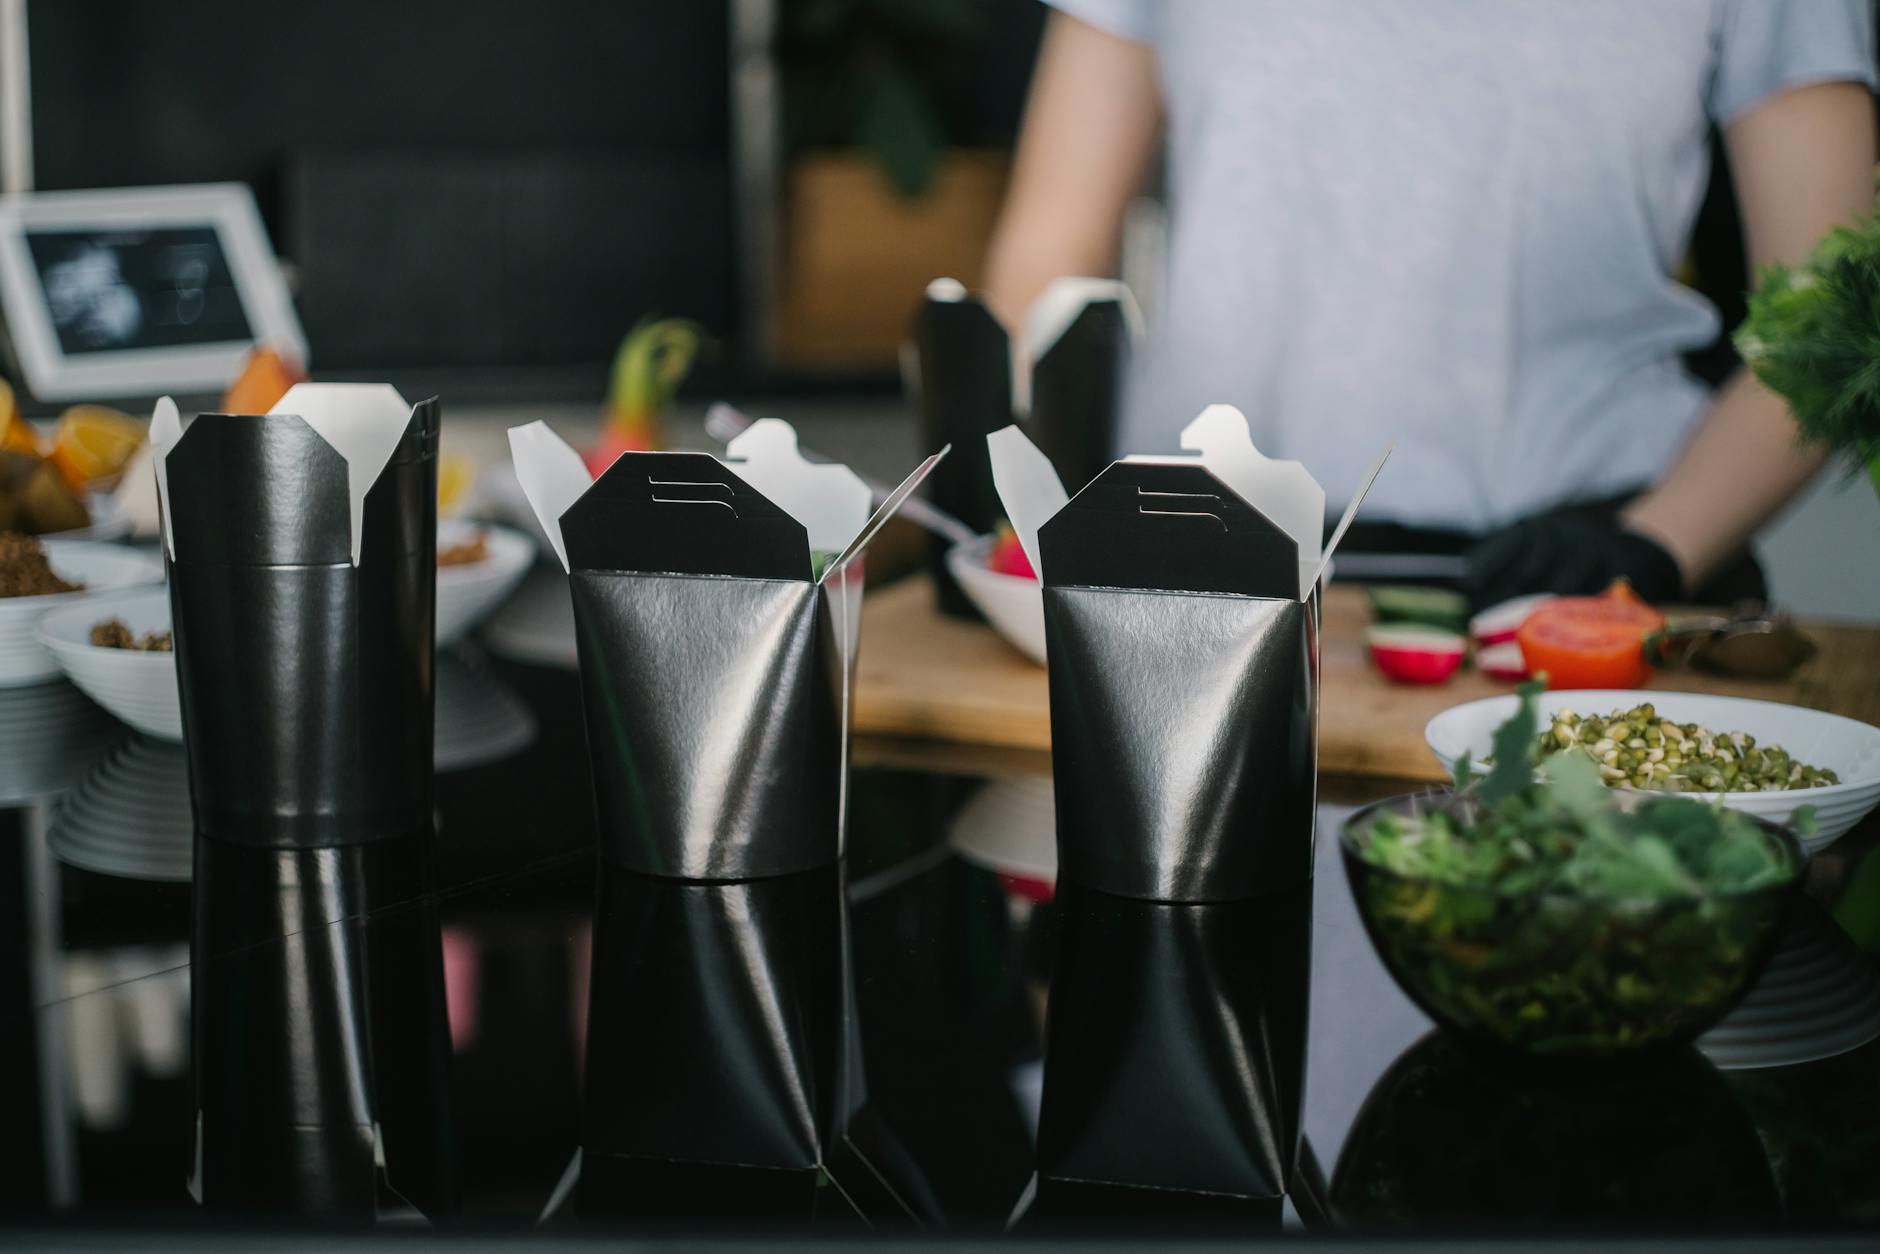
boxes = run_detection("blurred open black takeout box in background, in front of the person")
[910,276,1141,617]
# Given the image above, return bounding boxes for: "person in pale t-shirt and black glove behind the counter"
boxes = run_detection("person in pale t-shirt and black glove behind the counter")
[987,0,1874,603]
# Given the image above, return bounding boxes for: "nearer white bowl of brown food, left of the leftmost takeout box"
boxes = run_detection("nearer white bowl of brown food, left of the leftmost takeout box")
[39,590,182,741]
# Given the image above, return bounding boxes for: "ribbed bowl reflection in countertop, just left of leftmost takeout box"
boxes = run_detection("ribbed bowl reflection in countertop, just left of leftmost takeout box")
[45,735,196,882]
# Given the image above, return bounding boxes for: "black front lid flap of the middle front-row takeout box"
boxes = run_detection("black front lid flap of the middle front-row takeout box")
[562,453,810,583]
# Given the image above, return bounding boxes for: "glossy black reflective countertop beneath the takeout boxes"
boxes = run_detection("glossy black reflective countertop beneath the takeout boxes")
[0,651,1880,1241]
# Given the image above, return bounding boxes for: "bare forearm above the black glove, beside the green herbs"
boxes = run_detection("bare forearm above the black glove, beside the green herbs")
[1624,368,1824,588]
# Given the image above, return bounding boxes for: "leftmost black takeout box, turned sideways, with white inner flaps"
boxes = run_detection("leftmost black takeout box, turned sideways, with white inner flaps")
[152,384,438,848]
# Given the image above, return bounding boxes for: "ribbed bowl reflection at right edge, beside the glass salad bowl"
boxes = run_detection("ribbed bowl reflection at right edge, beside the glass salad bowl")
[1698,908,1880,1070]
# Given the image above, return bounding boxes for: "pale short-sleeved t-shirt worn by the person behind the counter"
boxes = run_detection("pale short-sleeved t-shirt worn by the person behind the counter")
[1051,0,1874,532]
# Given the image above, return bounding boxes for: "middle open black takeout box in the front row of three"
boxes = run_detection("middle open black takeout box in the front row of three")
[509,419,938,880]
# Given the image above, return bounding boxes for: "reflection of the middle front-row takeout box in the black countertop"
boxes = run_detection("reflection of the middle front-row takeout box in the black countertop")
[573,865,931,1222]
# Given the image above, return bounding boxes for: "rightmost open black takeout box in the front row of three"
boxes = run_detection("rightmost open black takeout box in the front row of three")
[987,406,1382,901]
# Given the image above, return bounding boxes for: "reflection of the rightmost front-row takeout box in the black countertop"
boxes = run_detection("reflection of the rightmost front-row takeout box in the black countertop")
[1028,880,1312,1222]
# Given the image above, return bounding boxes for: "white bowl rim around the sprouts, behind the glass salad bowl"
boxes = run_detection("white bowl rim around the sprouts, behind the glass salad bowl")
[1423,688,1880,854]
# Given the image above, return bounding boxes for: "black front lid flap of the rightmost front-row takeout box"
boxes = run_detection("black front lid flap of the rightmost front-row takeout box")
[1038,461,1299,602]
